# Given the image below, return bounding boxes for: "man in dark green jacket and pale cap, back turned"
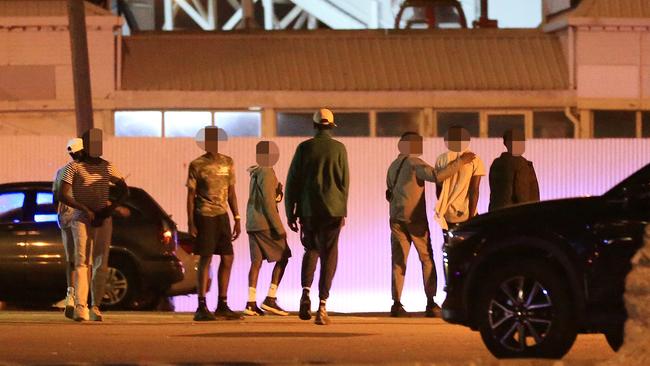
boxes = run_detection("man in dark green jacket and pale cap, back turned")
[285,109,350,325]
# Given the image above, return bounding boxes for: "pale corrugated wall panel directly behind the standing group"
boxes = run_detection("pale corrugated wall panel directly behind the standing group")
[0,136,650,311]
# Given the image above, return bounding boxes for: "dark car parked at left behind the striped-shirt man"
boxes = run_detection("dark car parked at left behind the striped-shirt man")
[0,182,183,309]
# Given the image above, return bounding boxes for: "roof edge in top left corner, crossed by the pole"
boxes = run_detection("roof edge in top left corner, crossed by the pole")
[0,0,113,17]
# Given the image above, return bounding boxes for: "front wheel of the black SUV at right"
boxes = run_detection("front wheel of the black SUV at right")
[475,260,577,358]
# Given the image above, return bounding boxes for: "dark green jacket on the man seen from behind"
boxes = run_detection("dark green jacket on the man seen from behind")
[284,131,350,221]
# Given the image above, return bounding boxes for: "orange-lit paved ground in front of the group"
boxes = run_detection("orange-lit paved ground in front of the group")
[0,311,614,366]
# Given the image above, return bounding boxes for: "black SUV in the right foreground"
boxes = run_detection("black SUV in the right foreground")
[443,165,650,358]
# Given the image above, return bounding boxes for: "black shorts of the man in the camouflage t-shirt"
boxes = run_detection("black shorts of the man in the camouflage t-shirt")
[194,214,234,257]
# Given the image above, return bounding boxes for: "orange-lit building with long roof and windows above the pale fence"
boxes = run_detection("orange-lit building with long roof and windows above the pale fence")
[0,0,650,138]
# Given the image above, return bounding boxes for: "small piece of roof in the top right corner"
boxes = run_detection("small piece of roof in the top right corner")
[572,0,650,18]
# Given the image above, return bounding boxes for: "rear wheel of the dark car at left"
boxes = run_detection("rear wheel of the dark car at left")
[102,260,138,309]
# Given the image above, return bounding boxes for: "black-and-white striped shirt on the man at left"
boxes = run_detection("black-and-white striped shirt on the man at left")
[63,159,122,220]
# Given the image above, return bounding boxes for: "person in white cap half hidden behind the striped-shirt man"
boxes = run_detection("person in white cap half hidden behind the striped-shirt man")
[52,138,83,319]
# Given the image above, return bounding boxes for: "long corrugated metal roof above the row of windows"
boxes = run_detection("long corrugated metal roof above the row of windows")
[122,29,568,91]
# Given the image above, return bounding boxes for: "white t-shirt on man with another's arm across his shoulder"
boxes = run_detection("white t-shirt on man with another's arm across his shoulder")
[435,150,485,229]
